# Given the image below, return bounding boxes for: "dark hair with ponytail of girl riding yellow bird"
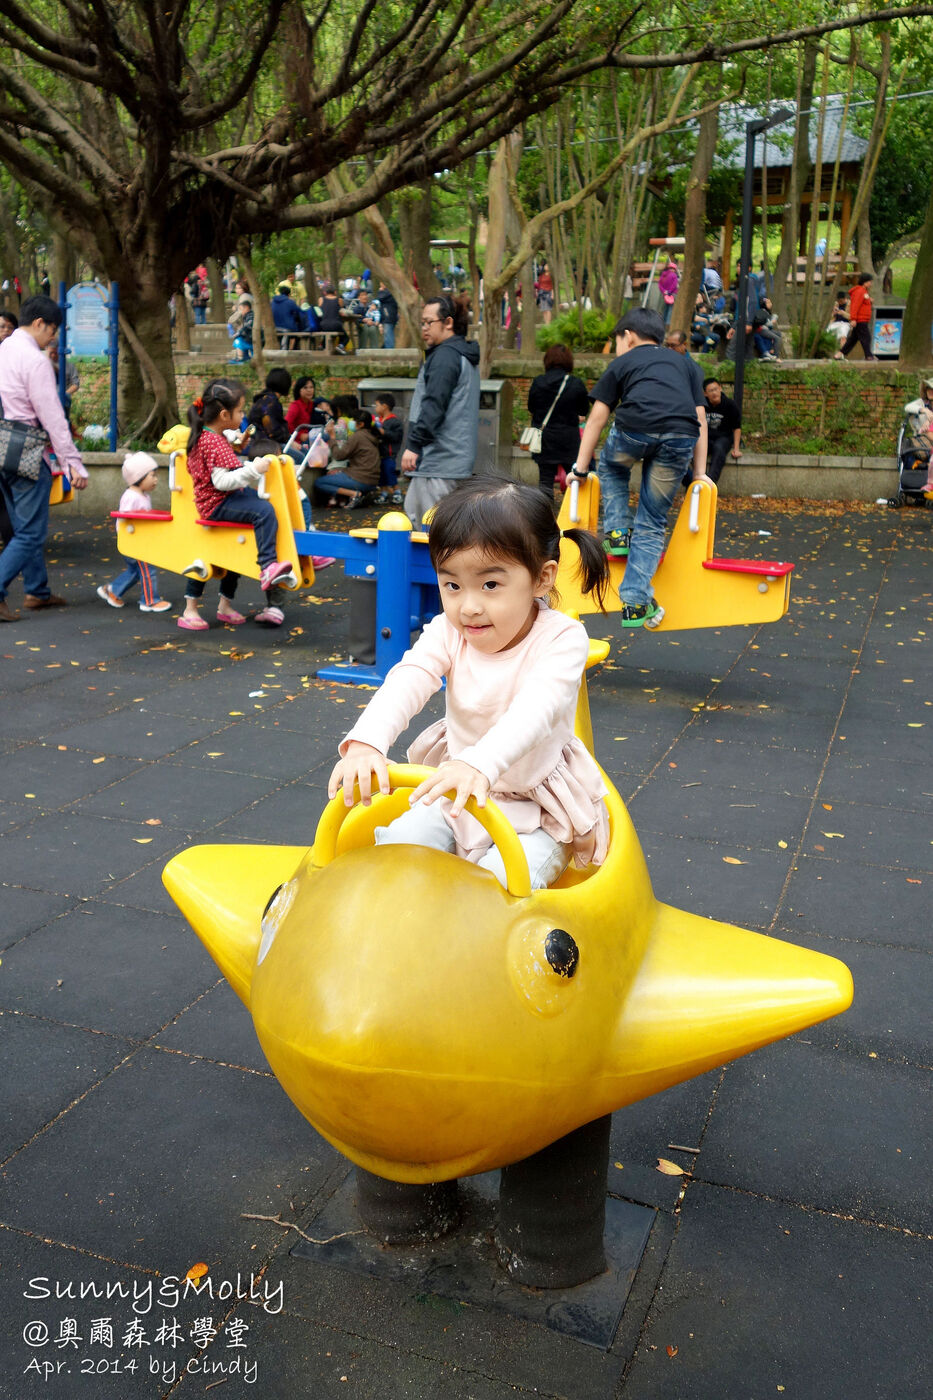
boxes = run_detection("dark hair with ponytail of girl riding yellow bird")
[427,476,609,610]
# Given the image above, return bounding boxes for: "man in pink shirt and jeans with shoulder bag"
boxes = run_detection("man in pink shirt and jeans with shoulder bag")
[0,297,87,622]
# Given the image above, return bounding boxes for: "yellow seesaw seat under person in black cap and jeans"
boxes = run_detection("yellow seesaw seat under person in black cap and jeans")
[556,472,794,631]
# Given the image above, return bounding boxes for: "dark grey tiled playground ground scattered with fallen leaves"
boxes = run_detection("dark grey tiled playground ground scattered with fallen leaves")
[0,503,933,1400]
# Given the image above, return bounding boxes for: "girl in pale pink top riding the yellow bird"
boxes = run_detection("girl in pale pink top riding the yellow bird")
[328,477,609,889]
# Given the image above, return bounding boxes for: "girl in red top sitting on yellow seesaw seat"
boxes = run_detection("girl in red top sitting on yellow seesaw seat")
[178,379,291,631]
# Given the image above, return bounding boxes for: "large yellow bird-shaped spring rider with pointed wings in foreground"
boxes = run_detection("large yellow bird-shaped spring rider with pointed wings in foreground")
[164,694,852,1183]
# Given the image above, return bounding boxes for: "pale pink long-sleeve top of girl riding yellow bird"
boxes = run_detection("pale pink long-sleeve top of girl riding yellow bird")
[340,603,609,865]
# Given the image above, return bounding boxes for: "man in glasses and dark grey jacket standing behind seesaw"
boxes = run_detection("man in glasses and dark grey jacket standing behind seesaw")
[401,297,479,529]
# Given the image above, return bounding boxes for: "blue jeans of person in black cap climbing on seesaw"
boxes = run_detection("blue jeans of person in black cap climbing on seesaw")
[598,424,696,608]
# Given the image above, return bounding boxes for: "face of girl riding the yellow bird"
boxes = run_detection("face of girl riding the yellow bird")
[437,546,558,655]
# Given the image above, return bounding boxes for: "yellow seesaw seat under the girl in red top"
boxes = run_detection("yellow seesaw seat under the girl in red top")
[111,427,314,588]
